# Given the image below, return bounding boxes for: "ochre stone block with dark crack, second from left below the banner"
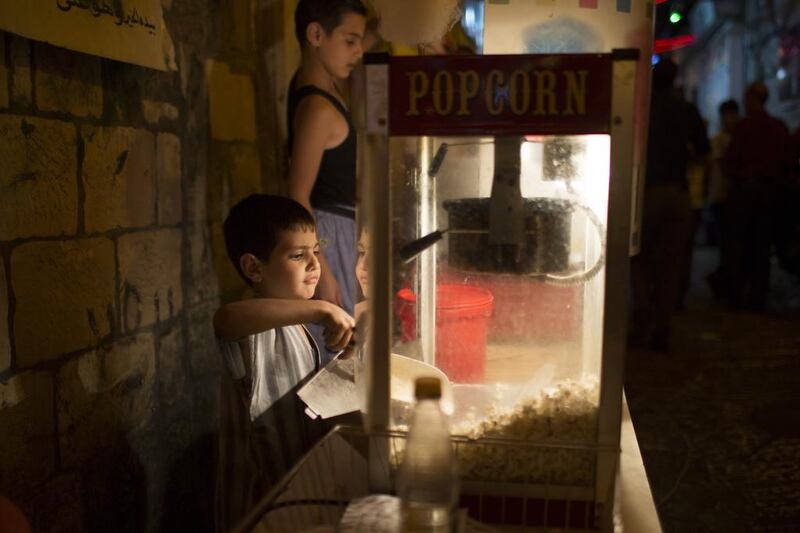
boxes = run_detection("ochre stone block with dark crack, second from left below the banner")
[82,127,156,232]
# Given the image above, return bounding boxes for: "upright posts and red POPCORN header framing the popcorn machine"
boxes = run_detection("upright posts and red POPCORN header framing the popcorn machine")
[357,49,639,530]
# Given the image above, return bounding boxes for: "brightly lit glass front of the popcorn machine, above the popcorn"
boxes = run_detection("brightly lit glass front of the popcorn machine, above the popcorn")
[389,135,610,439]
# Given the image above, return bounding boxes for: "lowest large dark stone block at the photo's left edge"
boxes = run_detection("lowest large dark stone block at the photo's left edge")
[0,372,56,492]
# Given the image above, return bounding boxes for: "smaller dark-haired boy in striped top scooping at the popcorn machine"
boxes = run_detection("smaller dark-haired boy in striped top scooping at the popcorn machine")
[214,194,355,531]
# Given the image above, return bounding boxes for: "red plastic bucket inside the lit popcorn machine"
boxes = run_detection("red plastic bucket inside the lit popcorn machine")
[397,285,494,383]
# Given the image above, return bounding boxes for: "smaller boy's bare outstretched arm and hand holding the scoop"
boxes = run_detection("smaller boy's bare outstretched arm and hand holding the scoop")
[214,298,355,350]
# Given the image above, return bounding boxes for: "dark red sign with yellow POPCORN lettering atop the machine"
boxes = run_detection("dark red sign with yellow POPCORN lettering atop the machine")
[389,54,611,135]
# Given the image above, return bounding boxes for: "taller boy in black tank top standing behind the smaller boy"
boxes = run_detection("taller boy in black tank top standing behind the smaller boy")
[288,0,367,362]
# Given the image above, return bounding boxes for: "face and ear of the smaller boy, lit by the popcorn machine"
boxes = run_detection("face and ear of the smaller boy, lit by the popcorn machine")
[257,230,320,300]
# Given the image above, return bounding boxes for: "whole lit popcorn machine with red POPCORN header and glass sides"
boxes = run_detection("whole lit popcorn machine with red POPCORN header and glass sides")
[356,3,646,530]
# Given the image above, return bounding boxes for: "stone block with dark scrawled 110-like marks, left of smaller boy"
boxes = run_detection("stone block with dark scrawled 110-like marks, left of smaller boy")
[118,229,183,332]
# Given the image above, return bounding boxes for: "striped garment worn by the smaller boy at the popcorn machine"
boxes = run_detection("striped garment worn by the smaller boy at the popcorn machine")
[214,326,324,531]
